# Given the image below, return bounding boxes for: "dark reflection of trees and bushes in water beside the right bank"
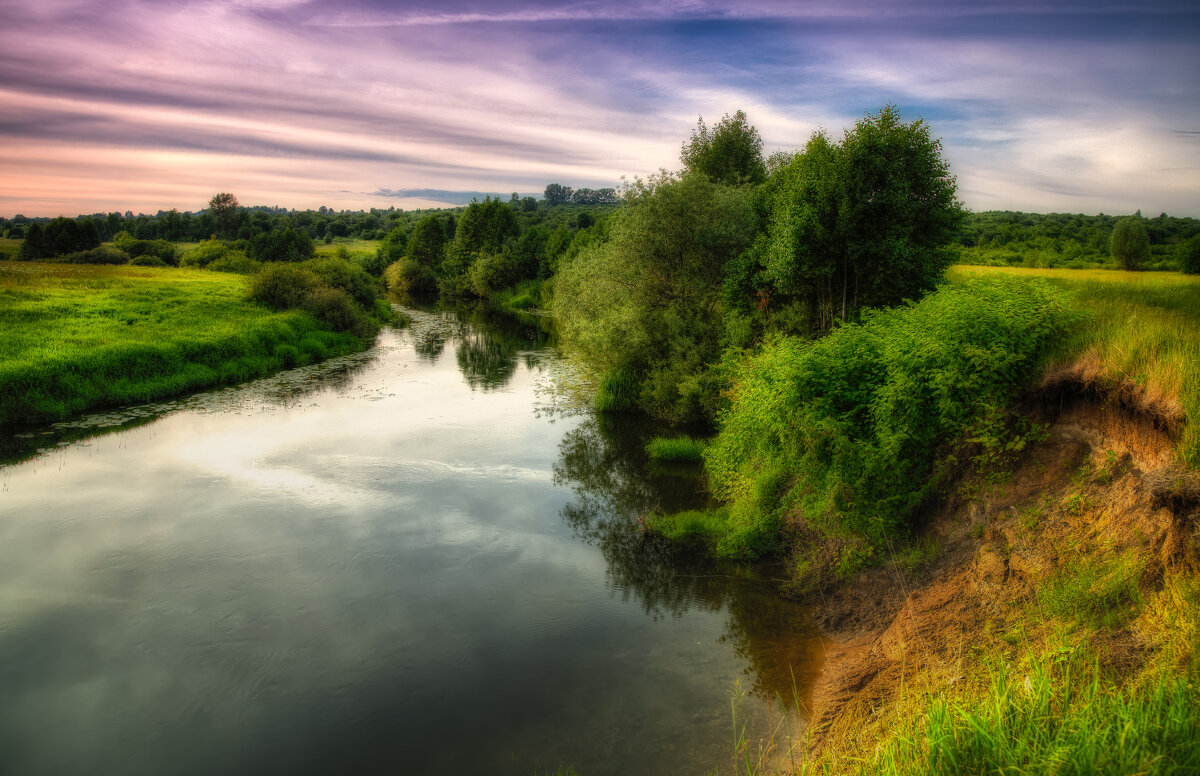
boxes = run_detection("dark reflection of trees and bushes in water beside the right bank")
[554,416,823,704]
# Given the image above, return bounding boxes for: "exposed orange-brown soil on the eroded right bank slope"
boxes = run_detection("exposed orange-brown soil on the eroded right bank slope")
[796,388,1200,753]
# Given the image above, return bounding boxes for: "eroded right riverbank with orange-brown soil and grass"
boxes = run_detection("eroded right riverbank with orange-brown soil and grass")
[777,267,1200,775]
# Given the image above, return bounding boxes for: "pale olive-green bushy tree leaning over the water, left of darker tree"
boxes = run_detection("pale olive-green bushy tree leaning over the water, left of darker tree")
[554,174,755,422]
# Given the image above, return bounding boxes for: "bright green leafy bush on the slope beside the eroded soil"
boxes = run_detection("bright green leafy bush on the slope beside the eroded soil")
[704,281,1072,558]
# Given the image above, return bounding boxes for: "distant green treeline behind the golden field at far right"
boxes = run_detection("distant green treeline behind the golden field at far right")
[958,210,1200,270]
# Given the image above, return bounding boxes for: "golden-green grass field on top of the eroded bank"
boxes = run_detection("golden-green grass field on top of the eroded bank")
[948,266,1200,468]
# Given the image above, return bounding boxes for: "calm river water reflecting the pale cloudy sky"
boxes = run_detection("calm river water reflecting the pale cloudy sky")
[0,304,822,776]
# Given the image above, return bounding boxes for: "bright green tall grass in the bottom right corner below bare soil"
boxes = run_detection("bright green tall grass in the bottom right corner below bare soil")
[858,652,1200,776]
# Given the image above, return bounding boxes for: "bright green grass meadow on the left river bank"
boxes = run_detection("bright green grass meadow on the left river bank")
[0,261,362,425]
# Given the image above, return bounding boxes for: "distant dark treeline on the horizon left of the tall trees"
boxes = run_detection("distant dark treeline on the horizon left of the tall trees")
[0,184,619,247]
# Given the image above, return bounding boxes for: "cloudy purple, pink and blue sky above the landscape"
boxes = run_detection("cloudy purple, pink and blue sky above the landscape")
[0,0,1200,216]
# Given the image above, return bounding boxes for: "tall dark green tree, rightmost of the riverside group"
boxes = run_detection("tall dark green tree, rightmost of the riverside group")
[744,106,962,329]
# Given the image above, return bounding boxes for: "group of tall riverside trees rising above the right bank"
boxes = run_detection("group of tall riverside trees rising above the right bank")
[554,107,962,422]
